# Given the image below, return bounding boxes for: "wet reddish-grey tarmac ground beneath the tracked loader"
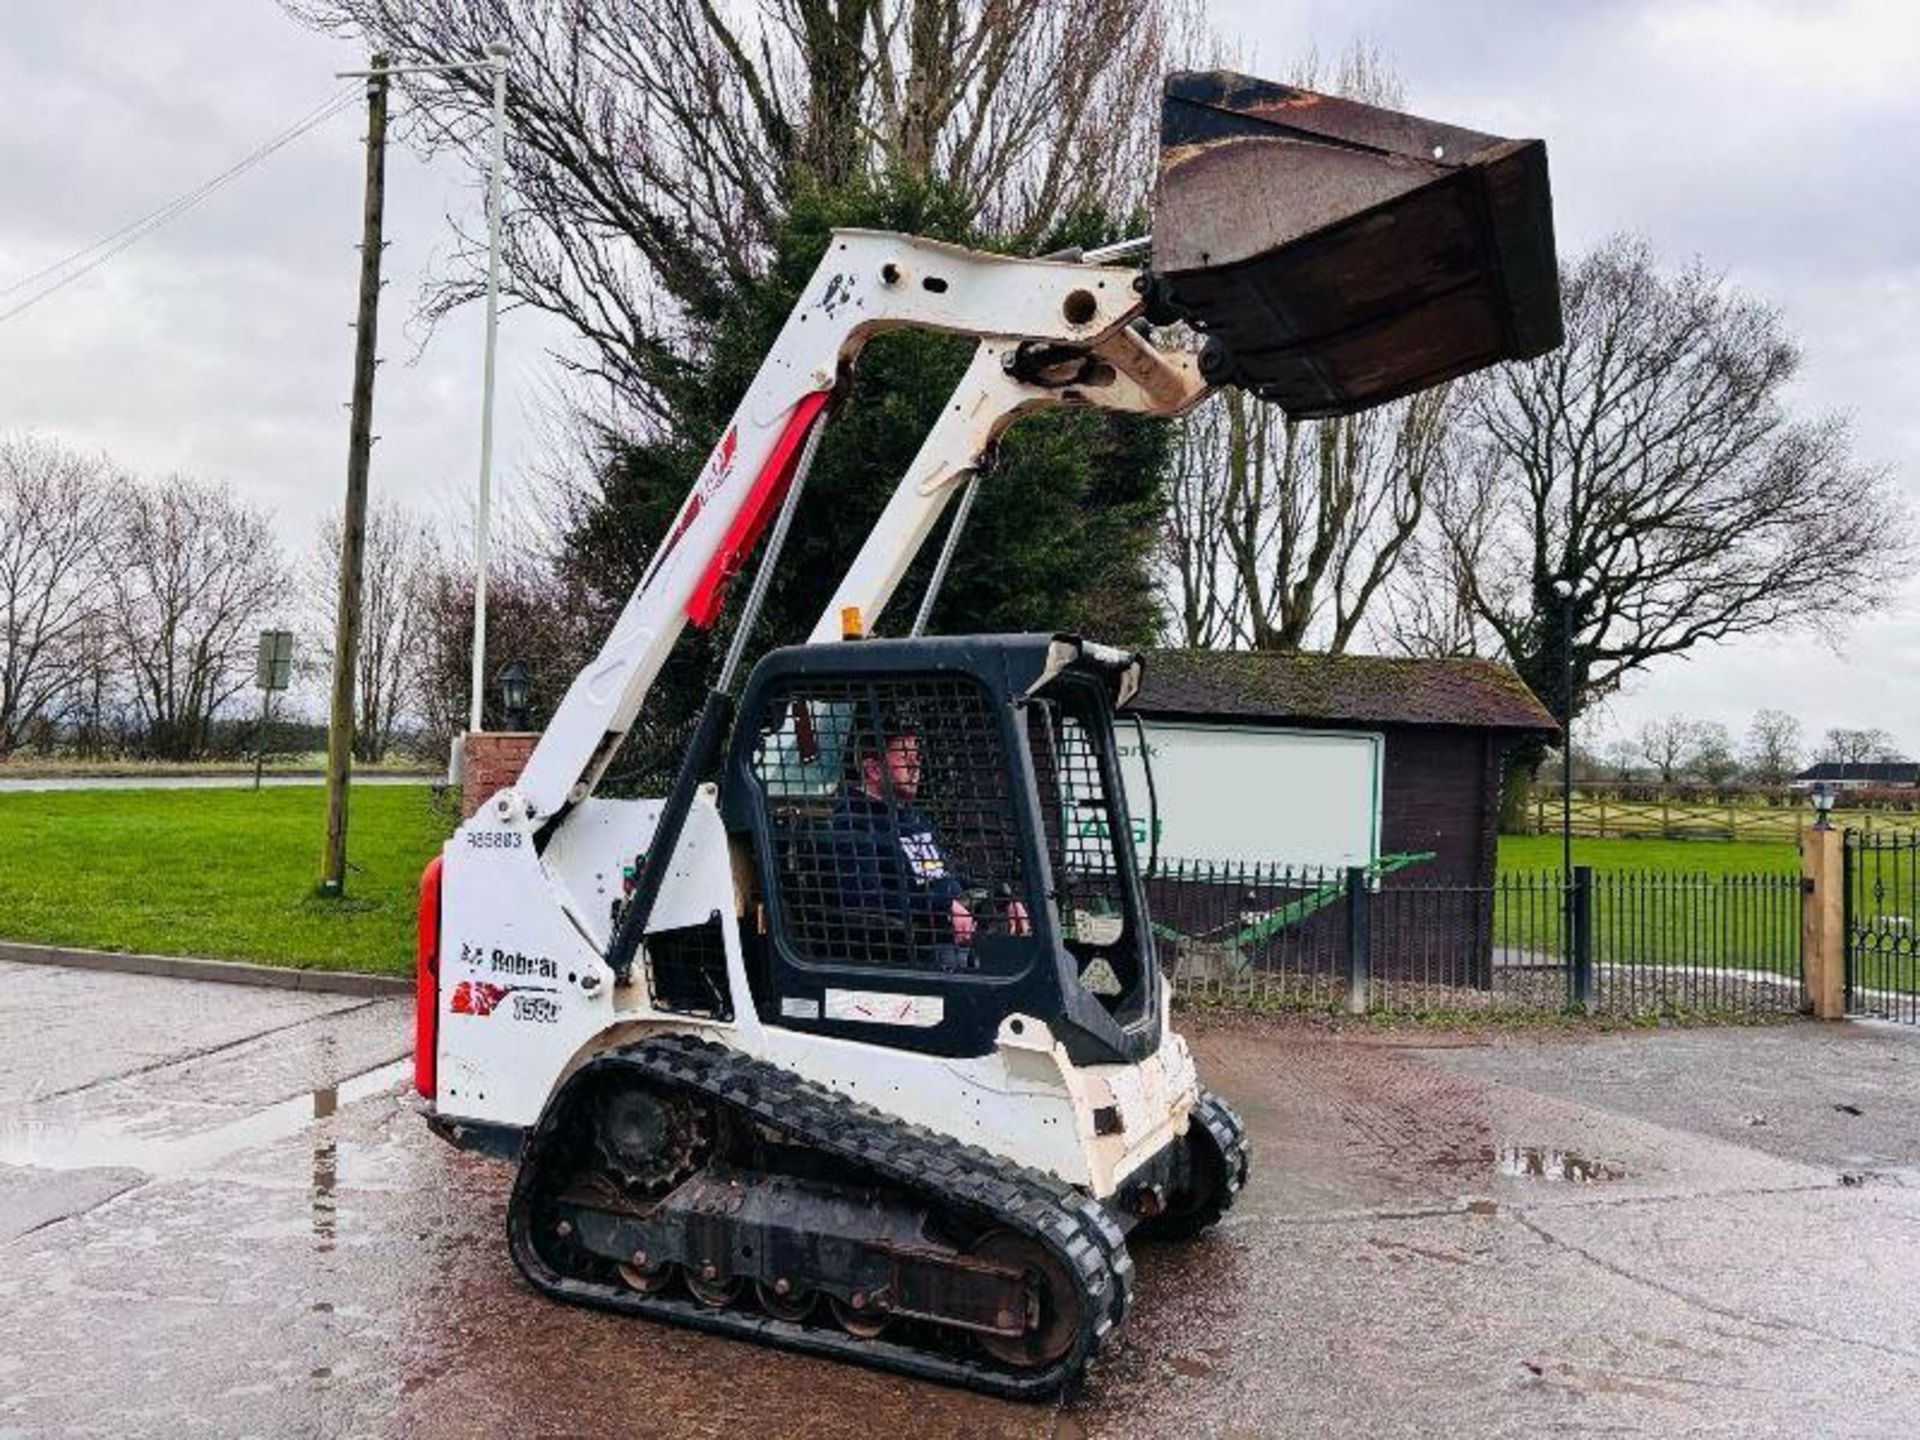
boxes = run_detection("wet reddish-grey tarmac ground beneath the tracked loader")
[0,966,1920,1438]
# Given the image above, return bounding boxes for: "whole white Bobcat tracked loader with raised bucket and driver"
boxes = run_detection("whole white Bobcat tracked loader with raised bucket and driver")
[417,75,1559,1396]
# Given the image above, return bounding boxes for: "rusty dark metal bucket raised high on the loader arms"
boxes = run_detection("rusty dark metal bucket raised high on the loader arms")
[1154,71,1561,419]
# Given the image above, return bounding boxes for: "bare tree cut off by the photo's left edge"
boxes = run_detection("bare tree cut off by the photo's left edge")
[0,436,117,756]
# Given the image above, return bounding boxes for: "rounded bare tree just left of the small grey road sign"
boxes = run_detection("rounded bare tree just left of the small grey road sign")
[109,474,286,758]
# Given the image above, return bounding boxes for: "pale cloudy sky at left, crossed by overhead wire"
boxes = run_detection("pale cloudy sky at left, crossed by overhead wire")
[0,0,564,622]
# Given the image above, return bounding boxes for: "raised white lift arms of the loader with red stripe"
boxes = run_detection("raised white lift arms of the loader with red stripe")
[516,230,1206,822]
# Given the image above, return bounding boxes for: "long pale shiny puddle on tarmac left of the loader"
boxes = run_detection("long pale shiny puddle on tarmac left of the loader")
[0,1056,413,1190]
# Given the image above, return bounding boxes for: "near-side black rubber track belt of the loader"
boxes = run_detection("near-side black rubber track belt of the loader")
[507,1035,1136,1400]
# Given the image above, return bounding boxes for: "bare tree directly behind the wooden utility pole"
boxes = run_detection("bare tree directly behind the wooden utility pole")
[301,501,434,764]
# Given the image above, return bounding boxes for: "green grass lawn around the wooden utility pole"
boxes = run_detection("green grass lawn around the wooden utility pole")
[0,785,451,975]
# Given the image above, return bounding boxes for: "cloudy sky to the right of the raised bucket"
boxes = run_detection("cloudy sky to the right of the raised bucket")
[1213,0,1920,753]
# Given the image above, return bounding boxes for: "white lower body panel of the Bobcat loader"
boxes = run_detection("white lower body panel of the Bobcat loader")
[434,791,1198,1194]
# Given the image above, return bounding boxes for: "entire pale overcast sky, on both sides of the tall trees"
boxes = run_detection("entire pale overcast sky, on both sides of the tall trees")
[0,0,1920,753]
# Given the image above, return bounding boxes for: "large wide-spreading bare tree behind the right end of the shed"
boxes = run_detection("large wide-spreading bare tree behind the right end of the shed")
[1438,238,1910,764]
